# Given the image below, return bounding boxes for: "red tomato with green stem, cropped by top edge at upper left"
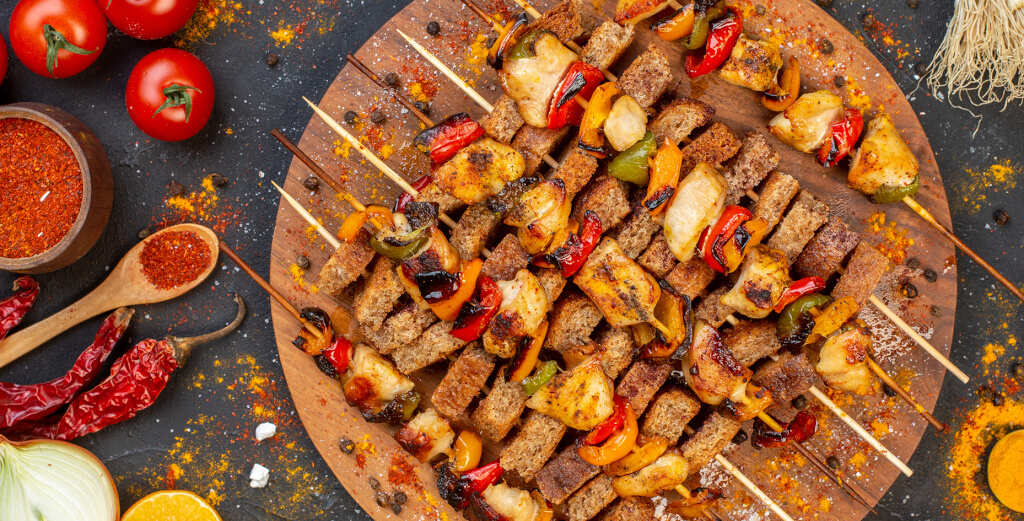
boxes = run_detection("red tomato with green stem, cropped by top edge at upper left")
[10,0,106,78]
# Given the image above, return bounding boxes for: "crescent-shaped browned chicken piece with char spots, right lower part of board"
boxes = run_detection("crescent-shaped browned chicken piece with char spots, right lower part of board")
[683,320,754,405]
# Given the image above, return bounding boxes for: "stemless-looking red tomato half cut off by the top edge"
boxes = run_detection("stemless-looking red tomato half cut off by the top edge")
[98,0,199,40]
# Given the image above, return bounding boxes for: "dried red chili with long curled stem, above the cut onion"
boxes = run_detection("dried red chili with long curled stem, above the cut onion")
[4,295,246,441]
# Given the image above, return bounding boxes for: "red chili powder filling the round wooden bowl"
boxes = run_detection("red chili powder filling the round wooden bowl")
[0,118,82,259]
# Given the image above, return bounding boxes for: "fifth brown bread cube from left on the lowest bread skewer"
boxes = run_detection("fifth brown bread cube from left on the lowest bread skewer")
[430,342,495,420]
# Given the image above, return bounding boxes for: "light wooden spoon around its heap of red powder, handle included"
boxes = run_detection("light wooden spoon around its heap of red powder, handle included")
[0,224,219,367]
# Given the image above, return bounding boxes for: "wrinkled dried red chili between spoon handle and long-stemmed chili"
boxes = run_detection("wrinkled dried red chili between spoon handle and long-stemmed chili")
[0,307,135,429]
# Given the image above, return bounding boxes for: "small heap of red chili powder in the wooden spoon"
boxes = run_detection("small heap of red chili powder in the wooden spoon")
[139,231,210,290]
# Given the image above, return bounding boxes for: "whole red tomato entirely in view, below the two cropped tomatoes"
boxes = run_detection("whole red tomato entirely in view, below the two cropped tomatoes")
[125,48,213,141]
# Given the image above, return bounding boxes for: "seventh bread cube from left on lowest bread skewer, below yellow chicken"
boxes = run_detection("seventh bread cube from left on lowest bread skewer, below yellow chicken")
[501,410,568,481]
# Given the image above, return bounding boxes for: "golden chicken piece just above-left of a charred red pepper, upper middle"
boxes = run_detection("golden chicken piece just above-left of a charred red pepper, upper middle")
[505,179,572,255]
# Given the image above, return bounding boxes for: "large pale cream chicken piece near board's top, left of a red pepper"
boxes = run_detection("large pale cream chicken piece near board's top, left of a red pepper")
[498,31,580,128]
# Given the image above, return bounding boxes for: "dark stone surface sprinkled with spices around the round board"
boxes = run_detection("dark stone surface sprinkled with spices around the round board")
[0,0,1024,520]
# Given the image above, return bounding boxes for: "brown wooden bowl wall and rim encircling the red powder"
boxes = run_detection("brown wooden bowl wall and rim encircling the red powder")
[0,102,92,271]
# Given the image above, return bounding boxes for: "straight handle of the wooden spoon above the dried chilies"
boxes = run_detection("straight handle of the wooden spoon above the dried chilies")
[0,285,113,367]
